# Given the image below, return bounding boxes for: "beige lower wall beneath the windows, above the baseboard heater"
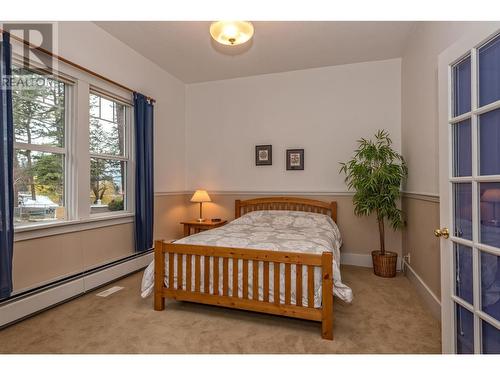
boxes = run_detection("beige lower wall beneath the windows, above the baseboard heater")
[12,223,134,293]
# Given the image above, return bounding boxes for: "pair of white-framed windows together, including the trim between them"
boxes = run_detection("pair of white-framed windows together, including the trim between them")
[12,54,134,233]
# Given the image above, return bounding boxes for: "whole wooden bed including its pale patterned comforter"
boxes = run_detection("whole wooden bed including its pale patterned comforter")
[142,197,352,340]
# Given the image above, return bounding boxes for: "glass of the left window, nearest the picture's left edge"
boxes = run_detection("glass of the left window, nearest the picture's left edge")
[12,66,68,226]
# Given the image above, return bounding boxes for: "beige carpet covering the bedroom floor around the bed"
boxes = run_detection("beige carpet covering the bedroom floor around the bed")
[0,266,441,353]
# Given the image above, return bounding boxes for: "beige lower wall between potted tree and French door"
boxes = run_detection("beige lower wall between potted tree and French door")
[402,195,441,299]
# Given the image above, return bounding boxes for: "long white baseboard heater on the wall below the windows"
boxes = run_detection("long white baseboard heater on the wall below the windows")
[0,253,153,327]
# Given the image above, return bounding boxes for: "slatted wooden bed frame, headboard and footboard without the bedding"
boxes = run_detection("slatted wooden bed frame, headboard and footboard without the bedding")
[154,197,337,340]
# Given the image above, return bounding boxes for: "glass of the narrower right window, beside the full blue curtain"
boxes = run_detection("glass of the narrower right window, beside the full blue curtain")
[89,93,130,214]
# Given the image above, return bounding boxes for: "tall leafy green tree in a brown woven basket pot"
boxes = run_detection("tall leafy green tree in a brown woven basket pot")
[340,130,408,277]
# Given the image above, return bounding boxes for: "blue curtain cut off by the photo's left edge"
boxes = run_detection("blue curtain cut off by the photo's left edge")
[0,32,14,299]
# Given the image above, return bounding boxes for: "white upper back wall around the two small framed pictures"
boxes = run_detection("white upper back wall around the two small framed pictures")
[186,59,401,192]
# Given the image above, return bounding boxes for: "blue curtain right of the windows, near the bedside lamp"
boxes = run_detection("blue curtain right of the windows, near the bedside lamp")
[134,93,154,252]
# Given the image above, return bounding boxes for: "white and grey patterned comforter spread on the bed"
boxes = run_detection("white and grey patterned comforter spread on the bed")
[141,211,352,307]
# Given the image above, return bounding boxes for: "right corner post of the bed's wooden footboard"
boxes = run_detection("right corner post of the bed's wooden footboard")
[321,252,333,340]
